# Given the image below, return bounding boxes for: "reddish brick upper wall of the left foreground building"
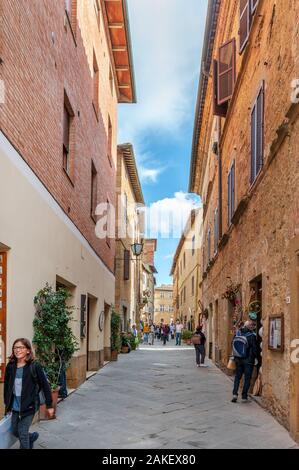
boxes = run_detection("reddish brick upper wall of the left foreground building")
[0,0,117,271]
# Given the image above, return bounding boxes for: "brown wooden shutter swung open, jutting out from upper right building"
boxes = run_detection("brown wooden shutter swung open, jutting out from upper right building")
[218,39,236,106]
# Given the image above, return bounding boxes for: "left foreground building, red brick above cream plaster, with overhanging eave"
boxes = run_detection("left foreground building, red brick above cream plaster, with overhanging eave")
[0,0,135,394]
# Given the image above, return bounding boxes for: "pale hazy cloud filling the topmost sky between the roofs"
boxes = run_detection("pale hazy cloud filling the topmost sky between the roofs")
[120,0,207,144]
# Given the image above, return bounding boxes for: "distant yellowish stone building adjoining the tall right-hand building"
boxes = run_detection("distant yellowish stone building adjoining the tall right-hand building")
[170,209,202,330]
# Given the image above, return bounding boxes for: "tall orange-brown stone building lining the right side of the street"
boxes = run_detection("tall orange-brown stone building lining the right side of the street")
[189,0,299,440]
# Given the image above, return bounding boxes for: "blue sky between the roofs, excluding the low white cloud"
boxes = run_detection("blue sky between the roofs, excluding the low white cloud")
[119,0,208,284]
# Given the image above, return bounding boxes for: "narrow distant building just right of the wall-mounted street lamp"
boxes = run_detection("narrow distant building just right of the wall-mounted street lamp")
[140,238,157,322]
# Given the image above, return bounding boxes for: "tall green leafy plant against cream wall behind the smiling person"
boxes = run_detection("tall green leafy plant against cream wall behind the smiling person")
[33,284,79,390]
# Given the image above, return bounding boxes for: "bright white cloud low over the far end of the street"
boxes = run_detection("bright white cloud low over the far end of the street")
[145,191,201,238]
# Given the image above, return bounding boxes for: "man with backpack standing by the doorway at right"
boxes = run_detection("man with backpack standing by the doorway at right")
[232,321,258,403]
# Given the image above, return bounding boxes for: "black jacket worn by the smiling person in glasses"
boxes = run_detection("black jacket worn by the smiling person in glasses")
[4,362,52,417]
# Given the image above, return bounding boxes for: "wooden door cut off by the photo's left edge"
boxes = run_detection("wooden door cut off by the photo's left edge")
[0,252,7,382]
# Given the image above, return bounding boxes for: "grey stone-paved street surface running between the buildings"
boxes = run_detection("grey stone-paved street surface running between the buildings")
[24,344,298,449]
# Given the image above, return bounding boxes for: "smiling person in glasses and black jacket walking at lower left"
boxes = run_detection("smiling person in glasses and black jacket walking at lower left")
[4,338,54,449]
